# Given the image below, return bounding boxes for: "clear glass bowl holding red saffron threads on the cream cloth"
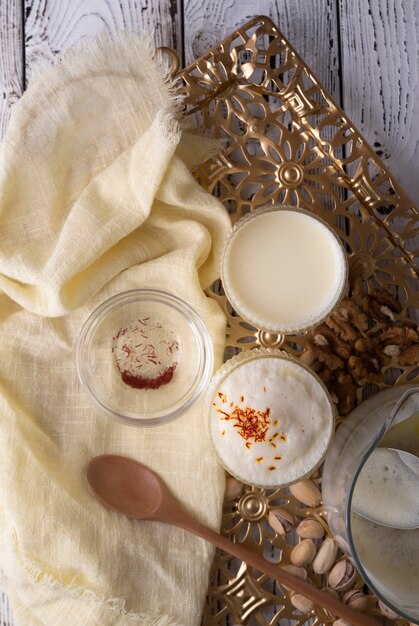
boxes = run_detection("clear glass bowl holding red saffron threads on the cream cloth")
[77,289,213,426]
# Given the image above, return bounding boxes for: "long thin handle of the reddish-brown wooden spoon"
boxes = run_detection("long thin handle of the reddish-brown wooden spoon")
[172,515,379,626]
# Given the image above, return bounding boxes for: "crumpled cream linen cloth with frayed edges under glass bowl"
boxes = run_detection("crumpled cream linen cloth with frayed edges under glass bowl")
[0,34,229,626]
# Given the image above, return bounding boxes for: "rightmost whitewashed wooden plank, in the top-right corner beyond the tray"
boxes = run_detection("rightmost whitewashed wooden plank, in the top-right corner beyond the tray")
[340,0,419,203]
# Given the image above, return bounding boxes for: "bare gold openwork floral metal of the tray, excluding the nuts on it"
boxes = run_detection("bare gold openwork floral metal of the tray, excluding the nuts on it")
[171,17,419,626]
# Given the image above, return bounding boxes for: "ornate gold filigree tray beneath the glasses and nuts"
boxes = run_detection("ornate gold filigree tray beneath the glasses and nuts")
[171,17,419,626]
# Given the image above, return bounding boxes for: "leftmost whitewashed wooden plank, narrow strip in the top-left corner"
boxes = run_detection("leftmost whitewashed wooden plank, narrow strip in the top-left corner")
[0,0,24,140]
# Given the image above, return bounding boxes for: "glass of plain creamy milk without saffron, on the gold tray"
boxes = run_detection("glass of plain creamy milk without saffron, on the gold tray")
[221,206,347,334]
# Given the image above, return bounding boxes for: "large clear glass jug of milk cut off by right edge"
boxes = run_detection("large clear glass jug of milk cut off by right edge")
[322,385,419,623]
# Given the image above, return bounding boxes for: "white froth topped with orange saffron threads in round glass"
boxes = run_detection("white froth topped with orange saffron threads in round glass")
[210,356,333,486]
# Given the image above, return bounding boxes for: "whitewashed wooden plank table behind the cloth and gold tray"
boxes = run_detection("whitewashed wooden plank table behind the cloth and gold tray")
[0,0,419,626]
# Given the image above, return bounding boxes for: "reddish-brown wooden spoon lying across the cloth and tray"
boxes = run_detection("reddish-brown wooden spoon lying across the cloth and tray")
[87,455,378,626]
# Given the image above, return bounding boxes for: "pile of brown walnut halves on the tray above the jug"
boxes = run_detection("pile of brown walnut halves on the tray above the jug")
[301,289,419,415]
